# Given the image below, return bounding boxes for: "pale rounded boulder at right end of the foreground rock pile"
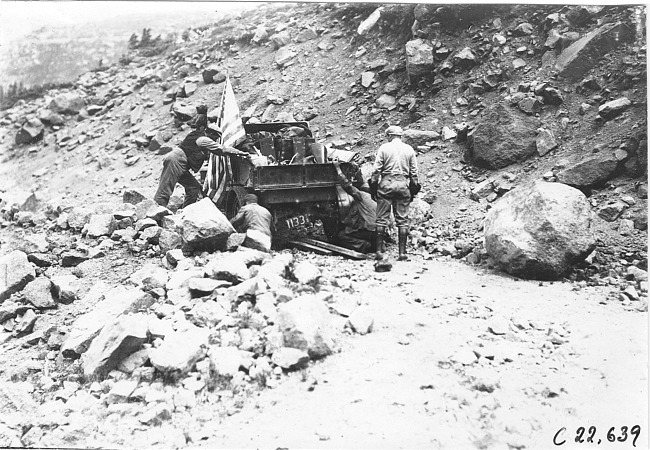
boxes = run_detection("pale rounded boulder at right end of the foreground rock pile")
[277,295,336,359]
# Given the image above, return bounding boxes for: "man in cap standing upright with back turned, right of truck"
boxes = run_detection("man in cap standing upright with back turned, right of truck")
[369,125,420,261]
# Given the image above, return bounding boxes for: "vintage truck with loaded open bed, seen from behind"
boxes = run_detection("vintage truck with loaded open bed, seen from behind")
[202,122,360,237]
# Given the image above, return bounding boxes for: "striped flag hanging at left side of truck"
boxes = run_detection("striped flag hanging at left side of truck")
[203,76,246,203]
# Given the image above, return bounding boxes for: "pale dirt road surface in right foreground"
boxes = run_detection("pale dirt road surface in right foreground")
[194,258,648,449]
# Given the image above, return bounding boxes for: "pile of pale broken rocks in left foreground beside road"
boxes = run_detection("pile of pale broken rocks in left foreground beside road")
[0,185,380,446]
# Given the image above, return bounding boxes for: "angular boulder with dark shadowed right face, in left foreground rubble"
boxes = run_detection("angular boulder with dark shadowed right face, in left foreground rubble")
[83,314,148,377]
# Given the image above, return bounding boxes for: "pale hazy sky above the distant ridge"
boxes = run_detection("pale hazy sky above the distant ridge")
[0,0,253,45]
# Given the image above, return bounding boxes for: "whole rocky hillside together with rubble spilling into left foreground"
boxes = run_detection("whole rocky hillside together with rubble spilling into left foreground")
[0,4,647,448]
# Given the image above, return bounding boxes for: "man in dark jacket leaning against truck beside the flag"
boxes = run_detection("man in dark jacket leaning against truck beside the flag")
[153,106,249,208]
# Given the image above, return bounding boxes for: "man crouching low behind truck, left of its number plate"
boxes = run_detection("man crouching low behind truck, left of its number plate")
[230,194,273,252]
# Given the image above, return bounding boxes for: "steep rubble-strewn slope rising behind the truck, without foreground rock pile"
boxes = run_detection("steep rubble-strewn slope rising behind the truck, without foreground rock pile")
[2,4,647,270]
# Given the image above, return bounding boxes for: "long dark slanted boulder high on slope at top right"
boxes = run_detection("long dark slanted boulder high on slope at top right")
[555,22,634,81]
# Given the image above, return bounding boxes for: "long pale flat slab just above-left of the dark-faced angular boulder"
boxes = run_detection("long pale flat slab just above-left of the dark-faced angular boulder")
[61,285,154,358]
